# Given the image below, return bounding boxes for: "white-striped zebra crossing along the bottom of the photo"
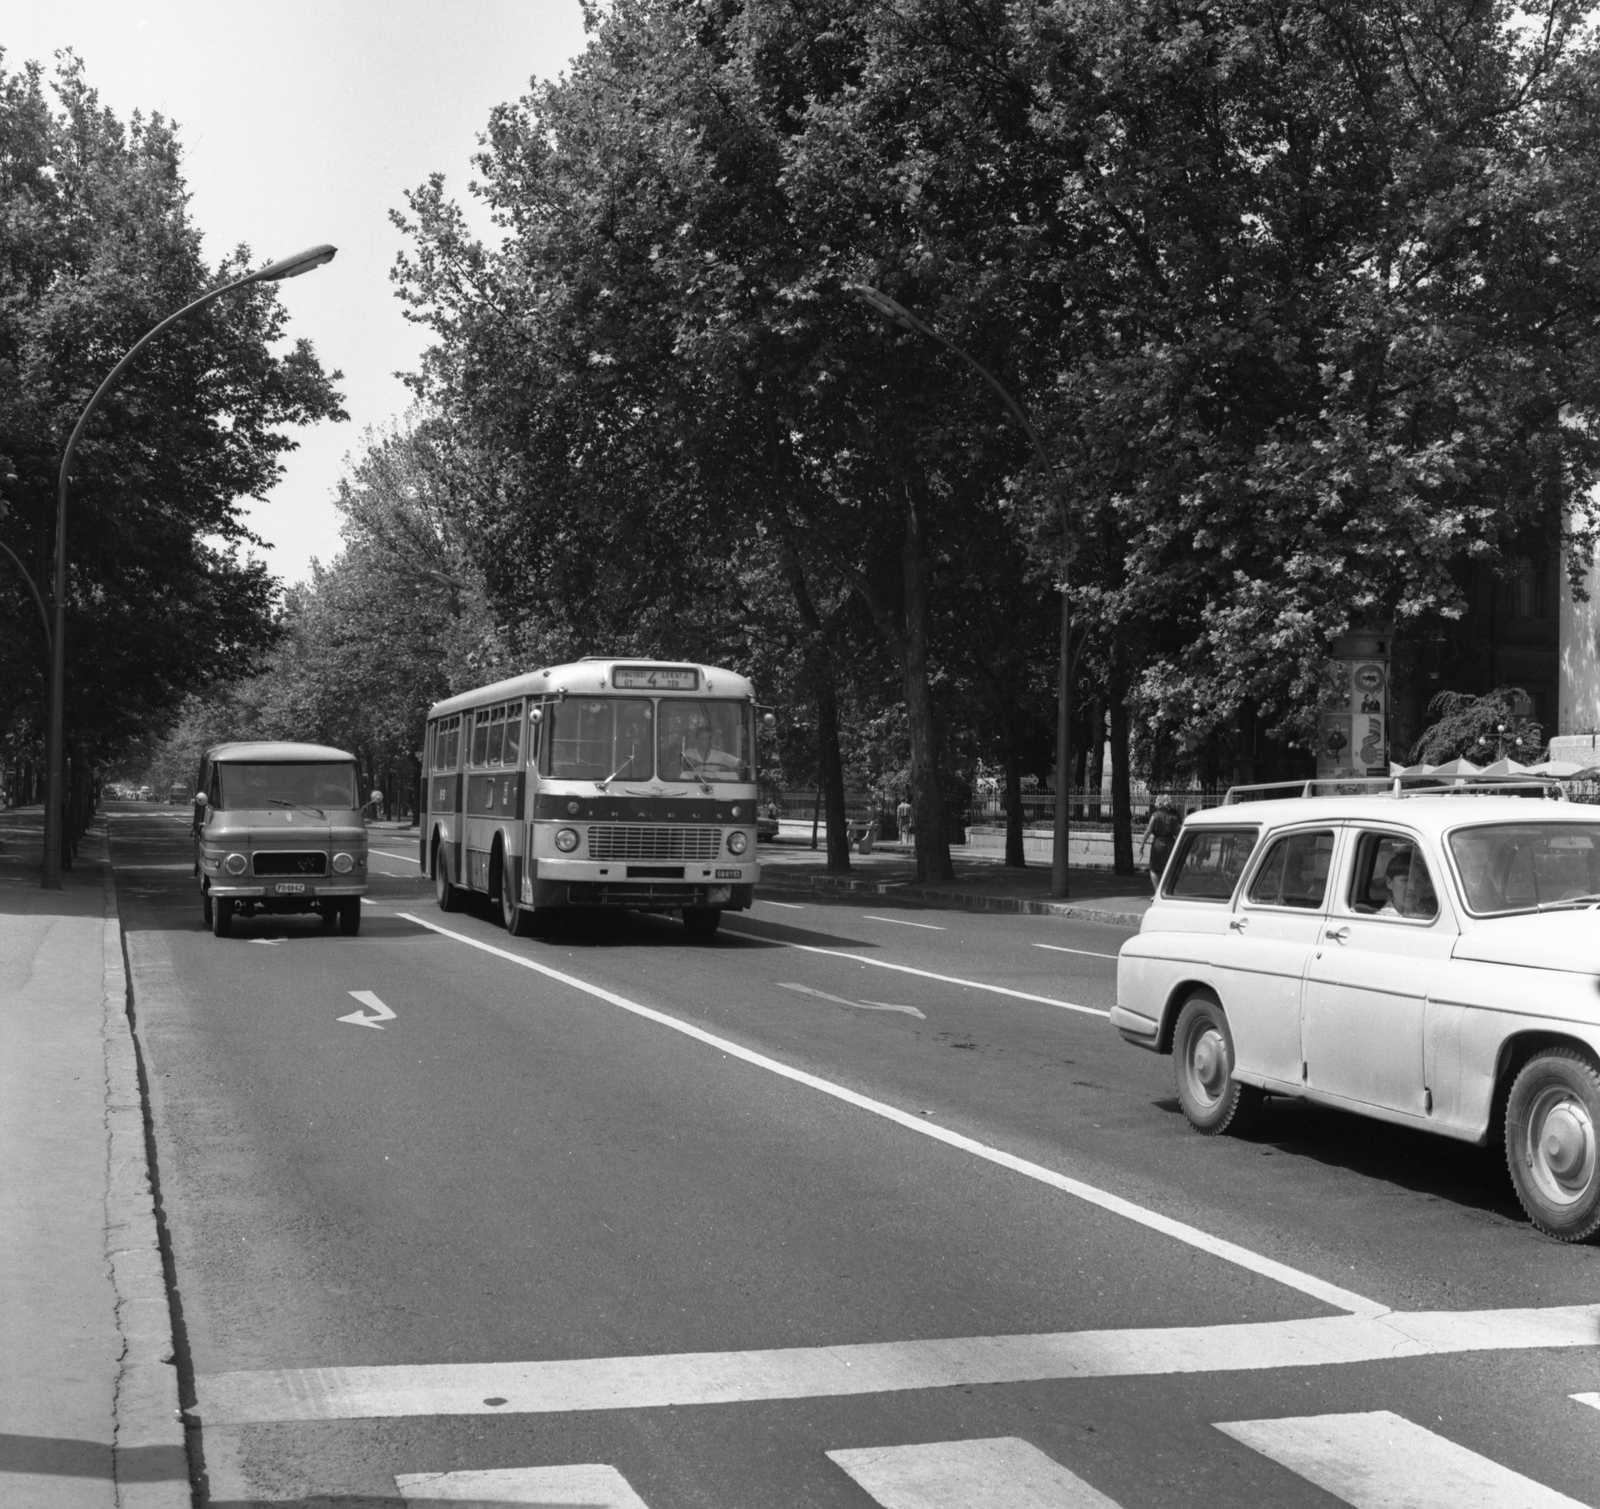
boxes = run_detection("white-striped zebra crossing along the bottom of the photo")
[380,1414,1597,1509]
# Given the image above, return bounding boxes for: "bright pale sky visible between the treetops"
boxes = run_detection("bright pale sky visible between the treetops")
[0,0,584,582]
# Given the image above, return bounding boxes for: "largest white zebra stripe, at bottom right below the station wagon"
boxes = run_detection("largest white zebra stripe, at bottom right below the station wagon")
[1218,1410,1586,1509]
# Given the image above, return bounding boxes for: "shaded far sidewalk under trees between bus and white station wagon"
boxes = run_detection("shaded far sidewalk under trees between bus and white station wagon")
[758,834,1150,928]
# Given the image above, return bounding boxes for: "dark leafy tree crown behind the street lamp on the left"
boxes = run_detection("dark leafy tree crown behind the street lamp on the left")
[0,54,342,784]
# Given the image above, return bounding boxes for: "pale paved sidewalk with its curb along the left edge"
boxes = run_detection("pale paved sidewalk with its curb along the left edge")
[0,807,190,1509]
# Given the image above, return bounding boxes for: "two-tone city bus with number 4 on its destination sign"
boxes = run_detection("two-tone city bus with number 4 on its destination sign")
[418,656,773,941]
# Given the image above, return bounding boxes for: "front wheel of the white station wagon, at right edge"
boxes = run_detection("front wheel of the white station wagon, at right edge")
[1506,1048,1600,1242]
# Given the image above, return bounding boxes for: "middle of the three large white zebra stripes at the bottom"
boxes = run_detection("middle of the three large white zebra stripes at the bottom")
[827,1435,1118,1509]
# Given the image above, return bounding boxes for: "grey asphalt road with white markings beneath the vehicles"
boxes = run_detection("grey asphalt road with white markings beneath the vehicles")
[110,805,1600,1509]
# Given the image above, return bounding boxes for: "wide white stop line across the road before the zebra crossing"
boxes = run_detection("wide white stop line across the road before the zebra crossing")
[195,1304,1600,1420]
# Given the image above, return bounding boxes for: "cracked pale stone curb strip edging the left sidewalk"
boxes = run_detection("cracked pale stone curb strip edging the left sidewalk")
[102,870,194,1509]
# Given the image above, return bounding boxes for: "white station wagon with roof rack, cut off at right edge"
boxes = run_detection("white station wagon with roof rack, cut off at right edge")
[1110,784,1600,1242]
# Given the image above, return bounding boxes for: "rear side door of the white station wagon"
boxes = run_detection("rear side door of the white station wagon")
[1218,824,1338,1091]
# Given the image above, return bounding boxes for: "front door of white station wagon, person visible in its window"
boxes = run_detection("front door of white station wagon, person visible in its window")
[1301,824,1456,1117]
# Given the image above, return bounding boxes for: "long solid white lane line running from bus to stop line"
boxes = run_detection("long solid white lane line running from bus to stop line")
[395,912,1387,1315]
